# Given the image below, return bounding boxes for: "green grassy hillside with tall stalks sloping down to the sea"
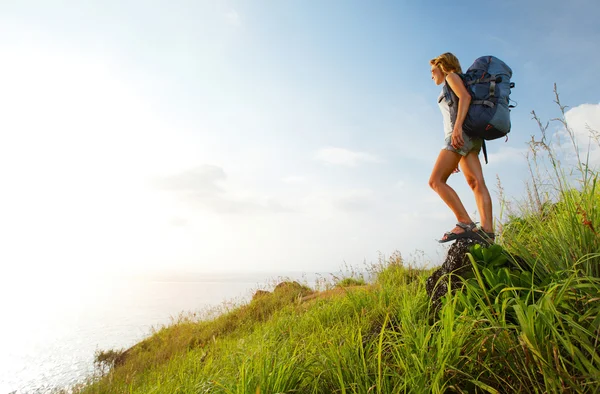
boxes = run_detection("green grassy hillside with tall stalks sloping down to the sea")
[69,91,600,394]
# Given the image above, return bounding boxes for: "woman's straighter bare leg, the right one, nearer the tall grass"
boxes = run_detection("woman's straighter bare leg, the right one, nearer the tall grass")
[460,152,494,233]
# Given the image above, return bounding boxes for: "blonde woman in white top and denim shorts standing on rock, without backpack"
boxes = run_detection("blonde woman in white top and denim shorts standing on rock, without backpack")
[429,52,494,242]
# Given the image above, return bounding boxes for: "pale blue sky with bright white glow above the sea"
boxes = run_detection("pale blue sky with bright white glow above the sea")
[0,0,600,275]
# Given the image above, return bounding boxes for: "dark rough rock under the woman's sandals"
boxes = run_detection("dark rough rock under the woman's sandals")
[425,238,487,311]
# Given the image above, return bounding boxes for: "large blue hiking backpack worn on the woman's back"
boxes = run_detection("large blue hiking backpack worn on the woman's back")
[444,56,515,164]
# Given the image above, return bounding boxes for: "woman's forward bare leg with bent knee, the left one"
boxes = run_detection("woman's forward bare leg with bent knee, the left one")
[429,149,472,234]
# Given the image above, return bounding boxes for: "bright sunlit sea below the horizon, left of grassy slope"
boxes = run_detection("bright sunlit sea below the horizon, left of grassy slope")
[0,273,329,394]
